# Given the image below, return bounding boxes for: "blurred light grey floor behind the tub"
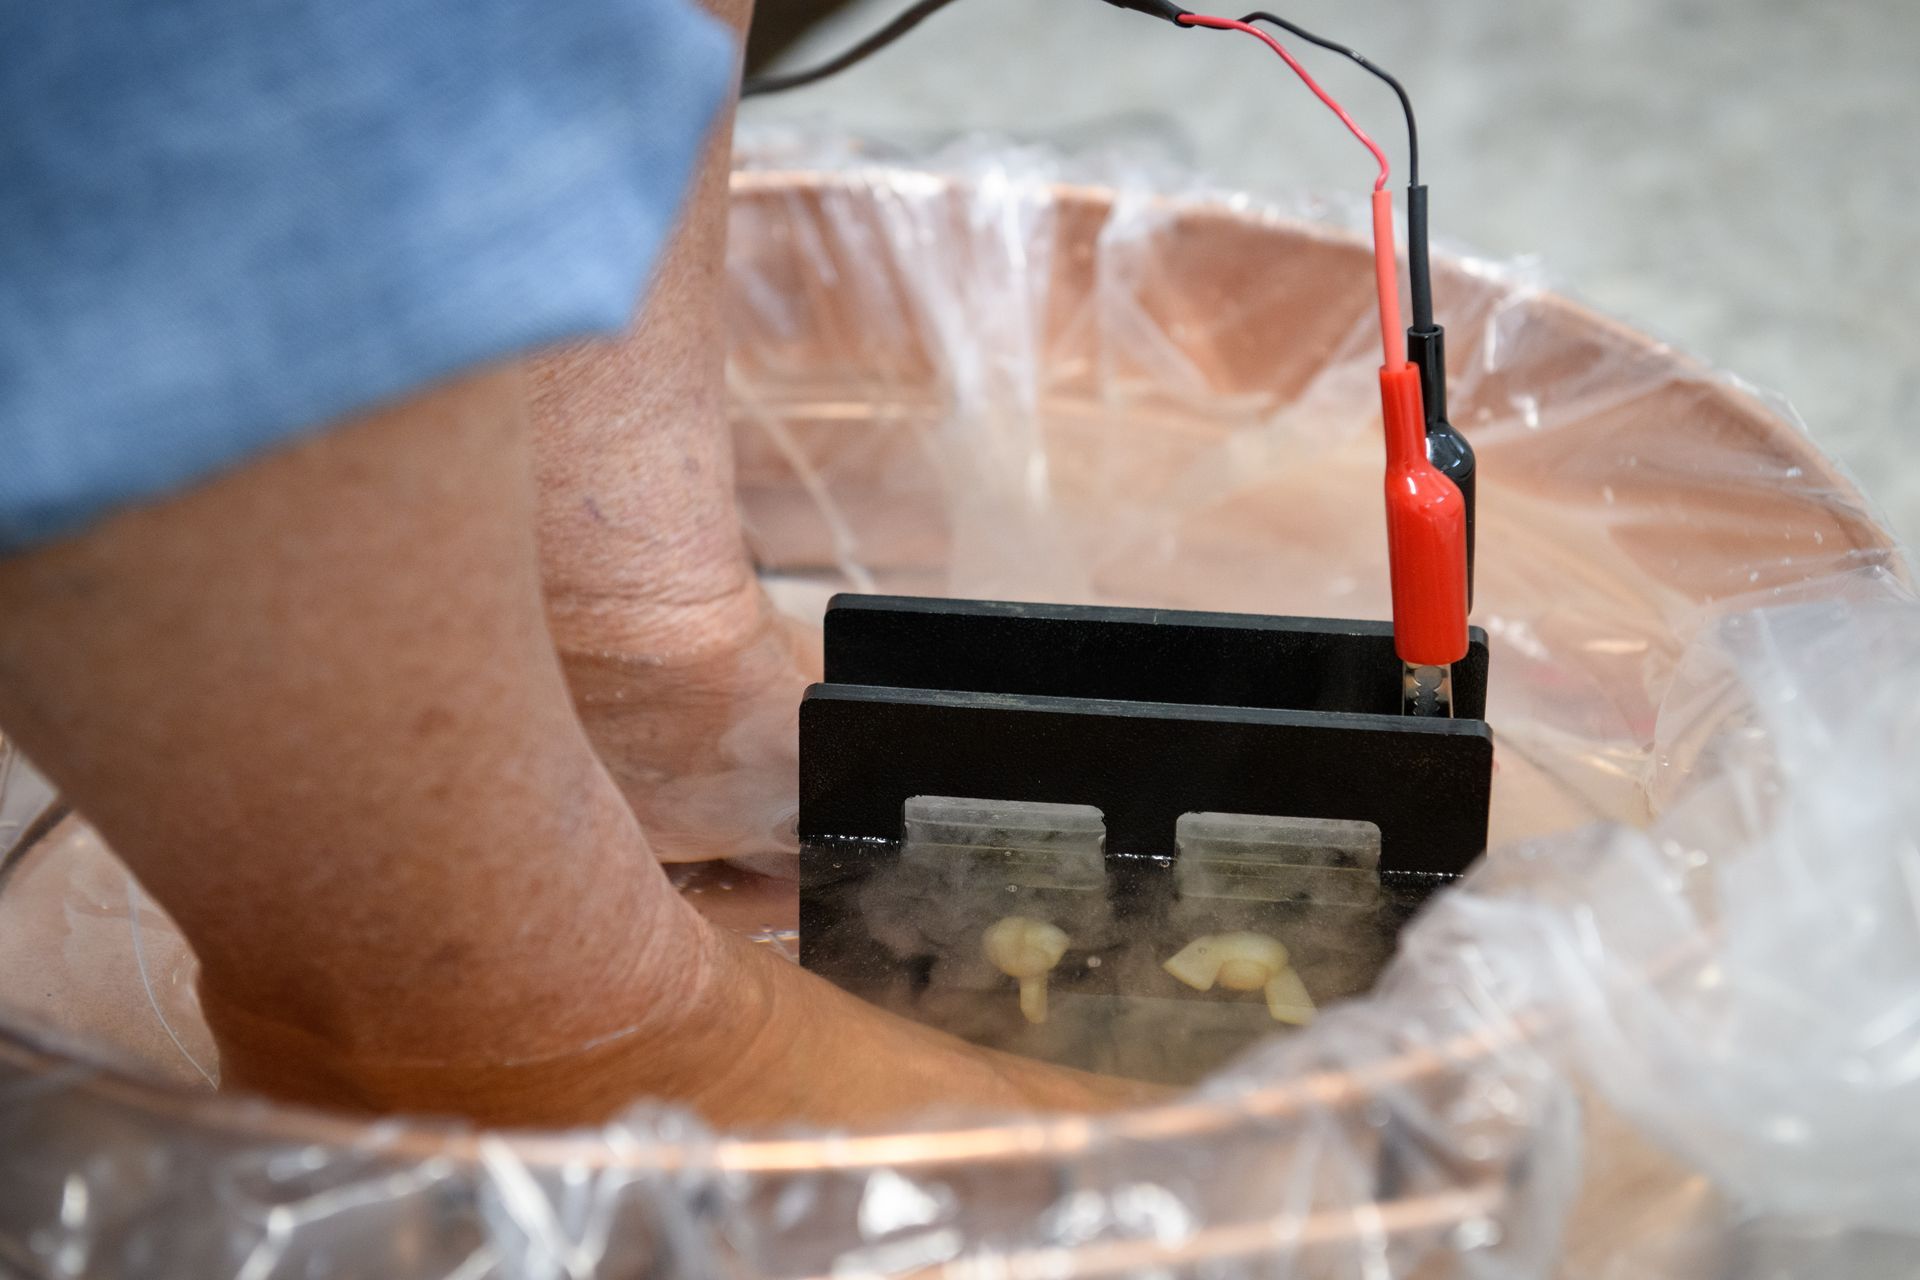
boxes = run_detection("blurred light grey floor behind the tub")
[743,0,1920,543]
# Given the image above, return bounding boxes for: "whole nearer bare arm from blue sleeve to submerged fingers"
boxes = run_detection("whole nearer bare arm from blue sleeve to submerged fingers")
[0,0,1140,1125]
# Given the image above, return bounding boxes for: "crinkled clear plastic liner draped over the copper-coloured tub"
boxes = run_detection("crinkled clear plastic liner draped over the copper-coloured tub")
[0,138,1920,1280]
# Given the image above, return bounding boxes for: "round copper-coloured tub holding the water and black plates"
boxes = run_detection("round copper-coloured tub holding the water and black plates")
[0,159,1905,1280]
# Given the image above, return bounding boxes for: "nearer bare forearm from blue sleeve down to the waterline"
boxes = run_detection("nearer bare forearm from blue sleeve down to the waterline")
[0,372,699,1105]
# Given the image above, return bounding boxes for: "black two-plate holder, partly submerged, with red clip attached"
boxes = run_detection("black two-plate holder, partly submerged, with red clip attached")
[799,595,1494,1082]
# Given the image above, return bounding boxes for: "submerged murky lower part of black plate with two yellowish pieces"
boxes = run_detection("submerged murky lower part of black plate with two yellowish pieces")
[801,796,1397,1084]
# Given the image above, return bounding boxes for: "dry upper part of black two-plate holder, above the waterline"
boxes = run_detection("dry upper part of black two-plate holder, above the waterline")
[799,595,1494,977]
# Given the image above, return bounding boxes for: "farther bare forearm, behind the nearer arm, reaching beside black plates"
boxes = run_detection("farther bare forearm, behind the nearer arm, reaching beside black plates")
[532,0,818,862]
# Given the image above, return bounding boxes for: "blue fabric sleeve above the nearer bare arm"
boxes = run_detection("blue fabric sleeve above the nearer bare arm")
[0,0,735,553]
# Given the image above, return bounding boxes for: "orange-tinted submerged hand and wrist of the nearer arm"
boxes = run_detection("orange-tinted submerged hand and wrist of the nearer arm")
[207,913,1167,1128]
